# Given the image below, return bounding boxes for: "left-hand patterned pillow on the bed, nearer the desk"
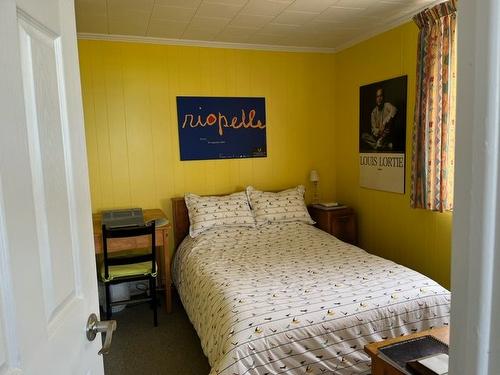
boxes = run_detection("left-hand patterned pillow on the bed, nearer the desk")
[184,191,255,238]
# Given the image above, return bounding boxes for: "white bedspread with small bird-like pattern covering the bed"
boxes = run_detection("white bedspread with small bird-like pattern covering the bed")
[173,223,450,375]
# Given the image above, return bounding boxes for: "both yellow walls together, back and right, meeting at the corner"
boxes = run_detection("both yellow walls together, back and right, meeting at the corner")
[79,23,452,287]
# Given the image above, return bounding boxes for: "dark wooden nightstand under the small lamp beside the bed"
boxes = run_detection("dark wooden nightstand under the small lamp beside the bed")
[307,206,358,245]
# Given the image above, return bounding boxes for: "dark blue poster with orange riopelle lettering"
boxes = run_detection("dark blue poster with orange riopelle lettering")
[177,96,267,160]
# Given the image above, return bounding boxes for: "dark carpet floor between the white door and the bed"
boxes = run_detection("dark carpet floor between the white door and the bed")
[104,293,210,375]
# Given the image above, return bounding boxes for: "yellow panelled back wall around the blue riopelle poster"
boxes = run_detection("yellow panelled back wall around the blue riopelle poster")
[78,40,335,245]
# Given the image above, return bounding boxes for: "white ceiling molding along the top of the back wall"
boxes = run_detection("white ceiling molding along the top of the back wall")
[77,33,336,53]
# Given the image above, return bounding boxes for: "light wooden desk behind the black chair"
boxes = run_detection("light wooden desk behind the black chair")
[92,209,172,312]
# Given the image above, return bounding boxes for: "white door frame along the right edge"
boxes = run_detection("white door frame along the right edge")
[449,0,500,375]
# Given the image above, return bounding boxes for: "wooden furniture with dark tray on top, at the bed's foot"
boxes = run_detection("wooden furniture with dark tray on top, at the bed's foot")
[365,327,450,375]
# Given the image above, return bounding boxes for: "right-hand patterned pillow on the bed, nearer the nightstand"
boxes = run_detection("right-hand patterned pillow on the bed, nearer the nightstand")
[247,185,314,225]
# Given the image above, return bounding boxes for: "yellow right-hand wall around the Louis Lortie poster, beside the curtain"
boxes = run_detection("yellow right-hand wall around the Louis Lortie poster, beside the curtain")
[334,23,452,287]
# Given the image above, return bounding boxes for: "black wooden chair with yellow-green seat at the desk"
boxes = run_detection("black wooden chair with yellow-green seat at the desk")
[99,221,158,327]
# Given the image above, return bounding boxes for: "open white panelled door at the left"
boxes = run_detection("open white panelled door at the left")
[0,0,103,375]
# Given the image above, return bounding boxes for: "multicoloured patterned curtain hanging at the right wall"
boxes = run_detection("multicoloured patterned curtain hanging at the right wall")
[411,0,457,212]
